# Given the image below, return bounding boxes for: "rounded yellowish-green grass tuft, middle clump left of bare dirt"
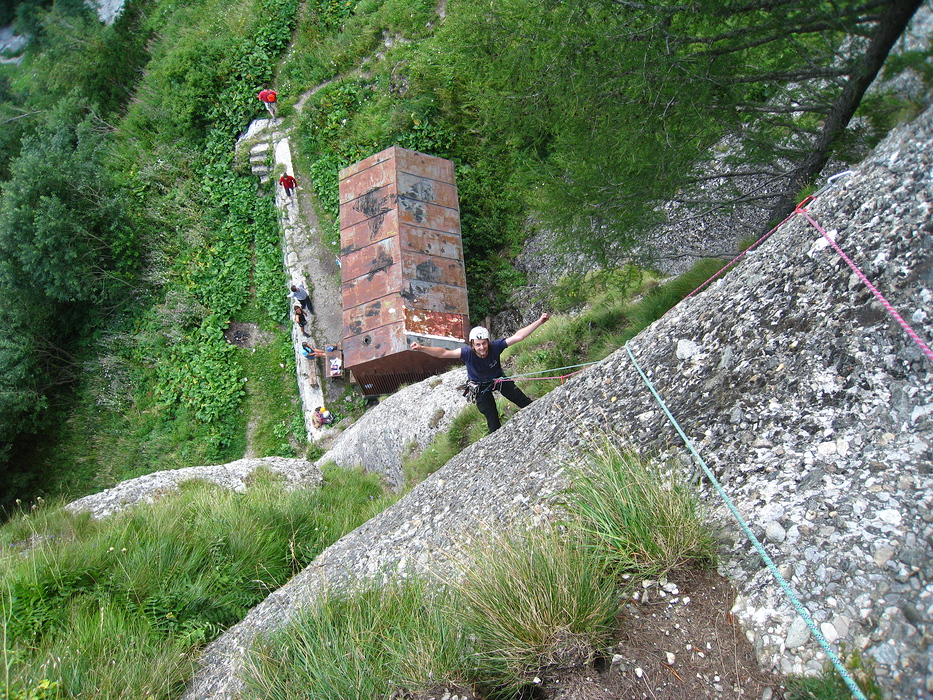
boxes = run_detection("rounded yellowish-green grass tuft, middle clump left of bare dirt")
[453,527,620,692]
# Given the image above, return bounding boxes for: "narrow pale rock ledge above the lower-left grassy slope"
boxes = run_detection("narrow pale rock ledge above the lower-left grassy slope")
[66,457,323,518]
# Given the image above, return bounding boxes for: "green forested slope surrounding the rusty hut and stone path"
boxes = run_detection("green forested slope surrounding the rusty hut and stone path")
[0,0,933,508]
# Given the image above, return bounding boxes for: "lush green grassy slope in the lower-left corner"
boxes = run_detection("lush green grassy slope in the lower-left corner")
[0,470,393,700]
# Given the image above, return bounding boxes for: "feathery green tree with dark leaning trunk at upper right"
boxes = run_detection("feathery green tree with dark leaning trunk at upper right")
[437,0,921,257]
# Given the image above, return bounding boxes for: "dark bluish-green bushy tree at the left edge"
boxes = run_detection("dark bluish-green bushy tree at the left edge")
[0,99,136,302]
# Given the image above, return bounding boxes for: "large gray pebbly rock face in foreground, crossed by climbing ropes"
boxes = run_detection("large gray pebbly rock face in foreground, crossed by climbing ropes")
[185,110,933,699]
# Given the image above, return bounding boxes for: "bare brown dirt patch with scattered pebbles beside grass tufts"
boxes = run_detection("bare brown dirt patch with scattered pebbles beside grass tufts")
[412,571,784,700]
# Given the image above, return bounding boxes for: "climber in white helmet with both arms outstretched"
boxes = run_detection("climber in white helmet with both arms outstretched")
[411,314,550,433]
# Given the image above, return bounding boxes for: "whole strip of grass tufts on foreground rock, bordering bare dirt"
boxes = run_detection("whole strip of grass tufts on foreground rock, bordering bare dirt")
[245,451,712,700]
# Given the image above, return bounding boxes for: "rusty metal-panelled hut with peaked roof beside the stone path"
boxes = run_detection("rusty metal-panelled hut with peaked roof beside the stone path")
[340,147,469,395]
